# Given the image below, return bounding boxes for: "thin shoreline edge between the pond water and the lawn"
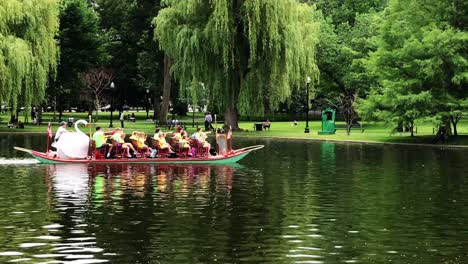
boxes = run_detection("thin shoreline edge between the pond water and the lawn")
[4,131,468,149]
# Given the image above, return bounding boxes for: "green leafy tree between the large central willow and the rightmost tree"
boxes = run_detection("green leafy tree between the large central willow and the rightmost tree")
[308,0,386,123]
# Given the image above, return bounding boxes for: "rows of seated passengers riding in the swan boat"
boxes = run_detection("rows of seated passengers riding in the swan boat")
[92,126,211,158]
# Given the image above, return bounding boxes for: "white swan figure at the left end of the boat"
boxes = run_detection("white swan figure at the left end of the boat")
[55,119,89,159]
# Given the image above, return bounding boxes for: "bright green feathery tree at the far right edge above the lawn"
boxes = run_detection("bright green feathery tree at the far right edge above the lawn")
[359,0,468,135]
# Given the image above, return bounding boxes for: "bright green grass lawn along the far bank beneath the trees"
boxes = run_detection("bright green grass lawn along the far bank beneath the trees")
[0,112,468,146]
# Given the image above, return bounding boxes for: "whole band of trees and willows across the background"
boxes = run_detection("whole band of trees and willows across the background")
[0,0,468,139]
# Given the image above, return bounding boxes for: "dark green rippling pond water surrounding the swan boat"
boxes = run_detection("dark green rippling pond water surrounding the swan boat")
[0,135,468,263]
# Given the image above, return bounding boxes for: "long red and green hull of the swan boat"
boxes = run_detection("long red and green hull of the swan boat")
[15,145,264,164]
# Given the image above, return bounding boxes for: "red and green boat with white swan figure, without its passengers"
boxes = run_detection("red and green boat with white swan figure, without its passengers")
[14,120,264,164]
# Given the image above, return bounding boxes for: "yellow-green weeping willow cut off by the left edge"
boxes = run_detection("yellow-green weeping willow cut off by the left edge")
[0,0,58,113]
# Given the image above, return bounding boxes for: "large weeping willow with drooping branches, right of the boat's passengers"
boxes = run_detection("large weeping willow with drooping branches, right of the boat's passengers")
[154,0,319,128]
